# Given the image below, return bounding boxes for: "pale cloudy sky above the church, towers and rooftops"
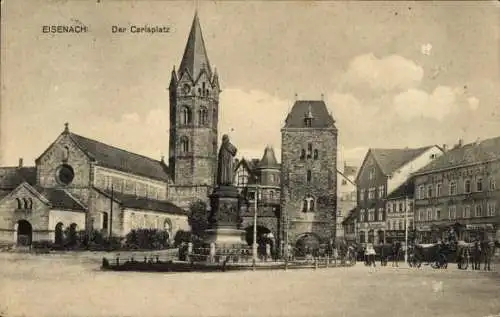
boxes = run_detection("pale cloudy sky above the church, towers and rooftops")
[0,0,500,166]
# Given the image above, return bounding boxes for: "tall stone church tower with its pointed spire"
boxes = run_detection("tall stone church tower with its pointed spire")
[169,13,220,188]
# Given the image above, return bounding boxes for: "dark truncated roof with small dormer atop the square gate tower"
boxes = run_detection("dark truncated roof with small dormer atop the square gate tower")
[285,100,335,128]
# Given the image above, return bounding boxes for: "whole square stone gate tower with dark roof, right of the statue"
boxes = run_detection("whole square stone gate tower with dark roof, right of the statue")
[281,100,337,247]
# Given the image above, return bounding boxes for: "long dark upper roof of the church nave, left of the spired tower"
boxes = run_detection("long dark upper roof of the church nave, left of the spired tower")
[68,132,170,181]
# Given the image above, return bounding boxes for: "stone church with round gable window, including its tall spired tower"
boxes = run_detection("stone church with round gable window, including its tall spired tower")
[0,15,220,245]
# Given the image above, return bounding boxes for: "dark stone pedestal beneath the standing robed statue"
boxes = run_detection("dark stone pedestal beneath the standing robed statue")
[205,186,247,249]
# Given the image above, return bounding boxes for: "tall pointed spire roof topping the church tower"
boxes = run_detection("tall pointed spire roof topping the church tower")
[179,12,212,80]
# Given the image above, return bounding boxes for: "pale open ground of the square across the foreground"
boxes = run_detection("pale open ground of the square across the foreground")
[0,253,500,317]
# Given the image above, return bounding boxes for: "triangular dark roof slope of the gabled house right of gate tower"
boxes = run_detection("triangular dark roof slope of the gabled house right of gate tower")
[369,146,433,176]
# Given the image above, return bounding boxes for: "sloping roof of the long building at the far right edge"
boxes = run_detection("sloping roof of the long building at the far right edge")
[415,137,500,175]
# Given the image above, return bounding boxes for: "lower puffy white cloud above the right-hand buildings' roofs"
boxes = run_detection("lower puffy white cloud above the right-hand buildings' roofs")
[393,86,457,120]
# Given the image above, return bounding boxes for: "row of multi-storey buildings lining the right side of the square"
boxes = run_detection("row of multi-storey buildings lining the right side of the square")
[342,137,500,244]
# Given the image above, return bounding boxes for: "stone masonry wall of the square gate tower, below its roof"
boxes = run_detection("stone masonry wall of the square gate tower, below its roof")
[281,128,337,242]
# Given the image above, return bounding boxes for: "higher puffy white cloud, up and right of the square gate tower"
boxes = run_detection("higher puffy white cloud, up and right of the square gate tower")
[345,53,424,92]
